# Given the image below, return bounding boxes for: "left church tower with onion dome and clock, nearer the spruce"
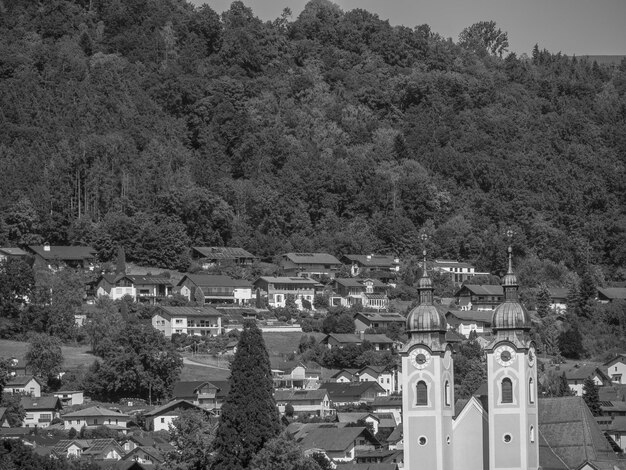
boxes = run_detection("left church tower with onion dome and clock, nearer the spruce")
[400,251,454,470]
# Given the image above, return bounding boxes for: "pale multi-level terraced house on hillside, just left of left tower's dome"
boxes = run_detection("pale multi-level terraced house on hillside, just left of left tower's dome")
[329,278,389,310]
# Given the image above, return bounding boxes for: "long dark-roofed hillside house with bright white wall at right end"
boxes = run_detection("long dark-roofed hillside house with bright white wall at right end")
[177,274,253,305]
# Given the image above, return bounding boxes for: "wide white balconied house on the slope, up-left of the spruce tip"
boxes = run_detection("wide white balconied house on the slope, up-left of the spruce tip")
[152,305,223,338]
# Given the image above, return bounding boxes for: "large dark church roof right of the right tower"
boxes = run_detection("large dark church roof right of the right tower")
[539,397,615,468]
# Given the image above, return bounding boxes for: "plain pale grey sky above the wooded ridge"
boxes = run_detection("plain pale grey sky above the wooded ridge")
[188,0,626,56]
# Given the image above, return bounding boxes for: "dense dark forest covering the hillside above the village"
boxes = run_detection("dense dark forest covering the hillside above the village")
[0,0,626,279]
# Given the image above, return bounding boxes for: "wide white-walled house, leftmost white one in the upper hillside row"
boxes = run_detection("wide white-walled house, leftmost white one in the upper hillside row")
[96,274,174,305]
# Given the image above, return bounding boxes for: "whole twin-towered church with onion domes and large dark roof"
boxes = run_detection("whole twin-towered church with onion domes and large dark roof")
[400,247,626,470]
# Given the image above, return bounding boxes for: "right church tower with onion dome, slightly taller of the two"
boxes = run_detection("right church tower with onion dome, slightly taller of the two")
[485,247,539,470]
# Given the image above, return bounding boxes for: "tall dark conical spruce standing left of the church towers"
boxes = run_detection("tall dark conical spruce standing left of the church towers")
[212,320,281,470]
